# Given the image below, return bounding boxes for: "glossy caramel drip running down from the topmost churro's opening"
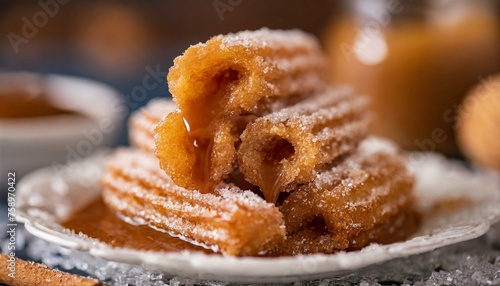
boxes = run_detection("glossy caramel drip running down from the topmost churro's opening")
[182,69,239,193]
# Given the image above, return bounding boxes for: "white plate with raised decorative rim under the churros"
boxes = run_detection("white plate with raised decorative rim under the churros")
[17,153,500,283]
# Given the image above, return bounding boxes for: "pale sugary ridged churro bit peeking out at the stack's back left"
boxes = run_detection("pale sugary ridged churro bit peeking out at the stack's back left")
[128,99,177,154]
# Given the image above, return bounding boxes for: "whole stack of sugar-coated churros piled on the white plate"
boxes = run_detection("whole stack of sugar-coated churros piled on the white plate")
[102,29,416,256]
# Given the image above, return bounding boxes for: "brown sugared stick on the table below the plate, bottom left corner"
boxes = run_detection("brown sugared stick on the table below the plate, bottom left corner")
[0,253,102,286]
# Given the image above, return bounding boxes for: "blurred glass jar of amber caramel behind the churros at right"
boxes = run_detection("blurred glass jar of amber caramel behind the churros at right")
[325,0,500,155]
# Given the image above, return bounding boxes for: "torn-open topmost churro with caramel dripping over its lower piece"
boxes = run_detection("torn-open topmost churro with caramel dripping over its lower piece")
[156,29,325,192]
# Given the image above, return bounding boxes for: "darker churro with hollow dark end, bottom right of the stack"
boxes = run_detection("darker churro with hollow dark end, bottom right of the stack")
[277,143,418,255]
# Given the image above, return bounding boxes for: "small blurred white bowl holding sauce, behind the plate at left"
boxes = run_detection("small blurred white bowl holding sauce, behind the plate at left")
[0,72,125,190]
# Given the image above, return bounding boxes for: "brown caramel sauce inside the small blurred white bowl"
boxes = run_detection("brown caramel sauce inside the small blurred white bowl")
[0,91,75,119]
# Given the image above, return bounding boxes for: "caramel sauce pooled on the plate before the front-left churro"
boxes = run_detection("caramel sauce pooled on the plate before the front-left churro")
[62,198,214,253]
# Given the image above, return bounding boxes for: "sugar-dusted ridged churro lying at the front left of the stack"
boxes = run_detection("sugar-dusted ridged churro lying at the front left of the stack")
[101,149,285,256]
